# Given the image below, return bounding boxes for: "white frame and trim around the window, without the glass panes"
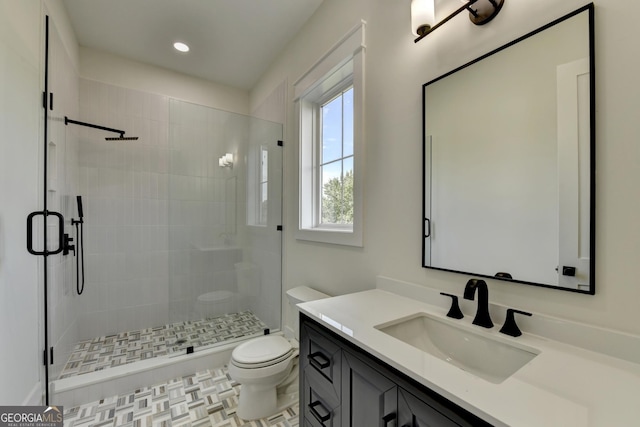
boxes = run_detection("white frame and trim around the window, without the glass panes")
[294,21,366,247]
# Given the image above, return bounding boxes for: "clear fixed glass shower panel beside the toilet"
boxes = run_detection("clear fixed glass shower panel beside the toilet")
[168,100,282,354]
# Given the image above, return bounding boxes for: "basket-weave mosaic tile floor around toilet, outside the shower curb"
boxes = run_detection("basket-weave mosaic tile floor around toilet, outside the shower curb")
[64,367,299,427]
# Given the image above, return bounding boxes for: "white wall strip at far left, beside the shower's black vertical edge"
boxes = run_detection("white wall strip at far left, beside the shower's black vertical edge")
[0,0,42,405]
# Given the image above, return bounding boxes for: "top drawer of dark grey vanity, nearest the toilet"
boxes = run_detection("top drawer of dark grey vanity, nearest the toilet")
[300,324,342,395]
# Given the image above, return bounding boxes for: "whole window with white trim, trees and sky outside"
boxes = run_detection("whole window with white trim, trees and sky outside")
[294,22,364,246]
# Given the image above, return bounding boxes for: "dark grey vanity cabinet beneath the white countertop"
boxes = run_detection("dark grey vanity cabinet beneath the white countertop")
[300,314,490,427]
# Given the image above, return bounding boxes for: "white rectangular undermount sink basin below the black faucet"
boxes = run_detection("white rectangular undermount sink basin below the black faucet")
[375,313,540,384]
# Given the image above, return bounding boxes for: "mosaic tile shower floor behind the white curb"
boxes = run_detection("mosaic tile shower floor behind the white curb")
[59,311,267,378]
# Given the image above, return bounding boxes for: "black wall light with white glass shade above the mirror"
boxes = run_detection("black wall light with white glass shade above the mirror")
[411,0,504,43]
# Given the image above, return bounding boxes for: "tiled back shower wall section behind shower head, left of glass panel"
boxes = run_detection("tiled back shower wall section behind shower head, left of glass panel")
[78,79,169,339]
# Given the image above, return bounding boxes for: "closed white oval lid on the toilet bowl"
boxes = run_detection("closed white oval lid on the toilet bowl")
[231,335,294,367]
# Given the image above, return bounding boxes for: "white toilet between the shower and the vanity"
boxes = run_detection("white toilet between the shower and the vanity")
[229,286,329,420]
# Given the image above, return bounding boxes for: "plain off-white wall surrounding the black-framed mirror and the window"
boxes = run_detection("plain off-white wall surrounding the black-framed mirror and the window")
[251,0,640,333]
